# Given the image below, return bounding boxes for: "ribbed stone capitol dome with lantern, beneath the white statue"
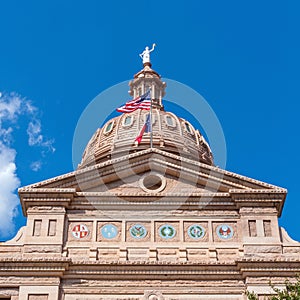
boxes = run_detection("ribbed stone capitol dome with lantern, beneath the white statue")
[79,63,213,168]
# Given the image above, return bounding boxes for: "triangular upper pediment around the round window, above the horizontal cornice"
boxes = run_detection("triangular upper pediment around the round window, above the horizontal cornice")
[19,149,286,193]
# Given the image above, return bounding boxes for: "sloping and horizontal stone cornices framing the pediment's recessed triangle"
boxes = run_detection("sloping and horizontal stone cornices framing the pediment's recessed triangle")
[19,149,287,215]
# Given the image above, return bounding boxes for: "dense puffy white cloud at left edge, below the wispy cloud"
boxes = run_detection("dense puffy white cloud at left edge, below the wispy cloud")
[0,142,20,236]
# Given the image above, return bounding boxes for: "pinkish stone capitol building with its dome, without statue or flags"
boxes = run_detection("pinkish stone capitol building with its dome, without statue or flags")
[0,64,300,300]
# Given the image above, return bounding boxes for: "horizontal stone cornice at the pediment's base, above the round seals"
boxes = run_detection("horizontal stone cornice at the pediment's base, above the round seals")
[19,187,286,214]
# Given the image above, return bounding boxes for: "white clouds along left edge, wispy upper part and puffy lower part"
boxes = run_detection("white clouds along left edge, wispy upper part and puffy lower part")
[0,92,55,237]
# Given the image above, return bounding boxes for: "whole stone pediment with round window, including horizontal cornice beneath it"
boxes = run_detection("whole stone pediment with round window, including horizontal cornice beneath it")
[19,149,287,215]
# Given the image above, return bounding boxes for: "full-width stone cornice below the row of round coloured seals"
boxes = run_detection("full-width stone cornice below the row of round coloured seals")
[0,258,300,279]
